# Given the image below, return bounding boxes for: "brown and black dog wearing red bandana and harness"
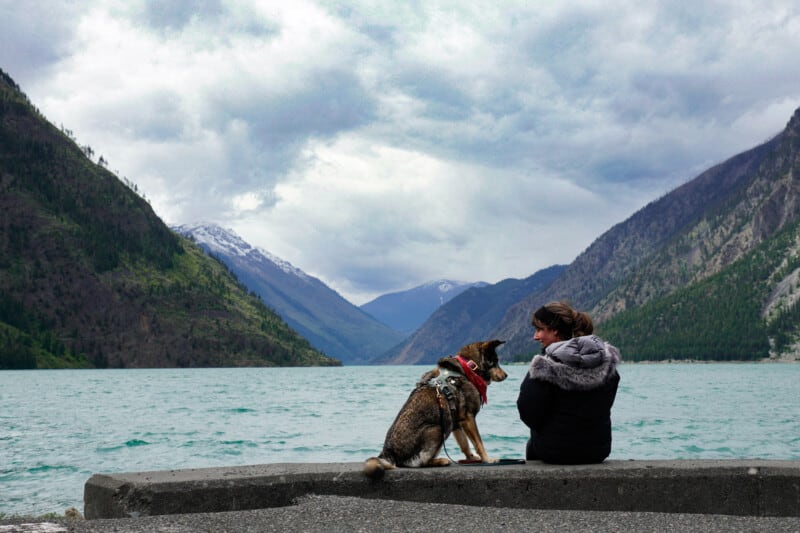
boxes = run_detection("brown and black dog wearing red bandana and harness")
[364,339,508,480]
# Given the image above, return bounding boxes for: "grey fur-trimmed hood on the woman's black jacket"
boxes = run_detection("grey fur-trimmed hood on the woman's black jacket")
[528,335,620,390]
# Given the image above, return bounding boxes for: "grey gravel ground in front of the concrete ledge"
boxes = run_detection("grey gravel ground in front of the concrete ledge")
[0,495,800,533]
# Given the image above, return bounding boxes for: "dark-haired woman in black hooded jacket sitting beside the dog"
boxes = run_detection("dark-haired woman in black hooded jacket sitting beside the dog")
[517,302,620,464]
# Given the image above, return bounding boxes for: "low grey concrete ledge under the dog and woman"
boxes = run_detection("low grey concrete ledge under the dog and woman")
[84,460,800,519]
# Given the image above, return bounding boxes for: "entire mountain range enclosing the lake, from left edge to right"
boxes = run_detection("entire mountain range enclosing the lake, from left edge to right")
[0,62,800,368]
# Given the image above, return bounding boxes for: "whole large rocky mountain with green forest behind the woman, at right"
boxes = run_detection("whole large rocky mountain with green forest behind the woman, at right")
[494,106,800,360]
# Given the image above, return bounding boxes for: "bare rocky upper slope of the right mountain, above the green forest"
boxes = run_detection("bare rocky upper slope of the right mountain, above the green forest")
[494,106,800,360]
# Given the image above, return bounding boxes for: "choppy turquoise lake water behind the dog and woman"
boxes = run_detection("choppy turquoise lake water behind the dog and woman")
[0,364,800,514]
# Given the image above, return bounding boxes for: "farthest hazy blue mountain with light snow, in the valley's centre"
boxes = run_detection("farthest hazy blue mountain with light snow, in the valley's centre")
[361,279,488,335]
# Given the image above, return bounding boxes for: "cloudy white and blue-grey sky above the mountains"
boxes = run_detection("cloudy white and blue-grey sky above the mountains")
[0,0,800,304]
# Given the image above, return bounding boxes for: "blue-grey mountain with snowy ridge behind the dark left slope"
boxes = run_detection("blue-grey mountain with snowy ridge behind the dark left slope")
[173,223,404,364]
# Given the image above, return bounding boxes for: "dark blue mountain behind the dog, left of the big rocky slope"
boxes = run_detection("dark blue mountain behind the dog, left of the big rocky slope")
[380,265,566,364]
